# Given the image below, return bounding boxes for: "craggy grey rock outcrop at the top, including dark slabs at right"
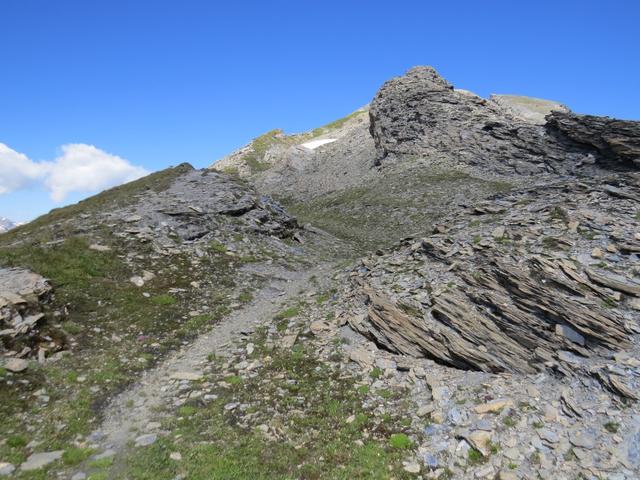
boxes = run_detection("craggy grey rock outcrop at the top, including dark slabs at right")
[369,67,640,174]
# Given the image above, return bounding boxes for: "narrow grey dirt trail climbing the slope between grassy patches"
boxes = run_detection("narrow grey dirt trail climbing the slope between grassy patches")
[94,265,330,454]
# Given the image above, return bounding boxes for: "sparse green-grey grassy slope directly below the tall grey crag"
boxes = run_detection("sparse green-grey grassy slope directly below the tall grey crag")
[278,168,512,254]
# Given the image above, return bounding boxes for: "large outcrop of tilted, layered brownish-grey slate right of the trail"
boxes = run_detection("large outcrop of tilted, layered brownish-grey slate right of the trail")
[351,175,640,397]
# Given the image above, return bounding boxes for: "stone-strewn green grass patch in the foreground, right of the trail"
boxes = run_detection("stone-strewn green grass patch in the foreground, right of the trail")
[110,339,414,480]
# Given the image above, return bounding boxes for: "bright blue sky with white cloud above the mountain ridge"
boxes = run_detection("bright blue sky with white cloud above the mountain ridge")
[0,0,640,220]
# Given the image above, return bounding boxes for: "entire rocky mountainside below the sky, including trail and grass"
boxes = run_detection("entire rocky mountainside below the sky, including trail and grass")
[0,67,640,480]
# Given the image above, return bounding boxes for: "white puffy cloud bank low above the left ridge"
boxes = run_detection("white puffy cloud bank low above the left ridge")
[0,143,149,202]
